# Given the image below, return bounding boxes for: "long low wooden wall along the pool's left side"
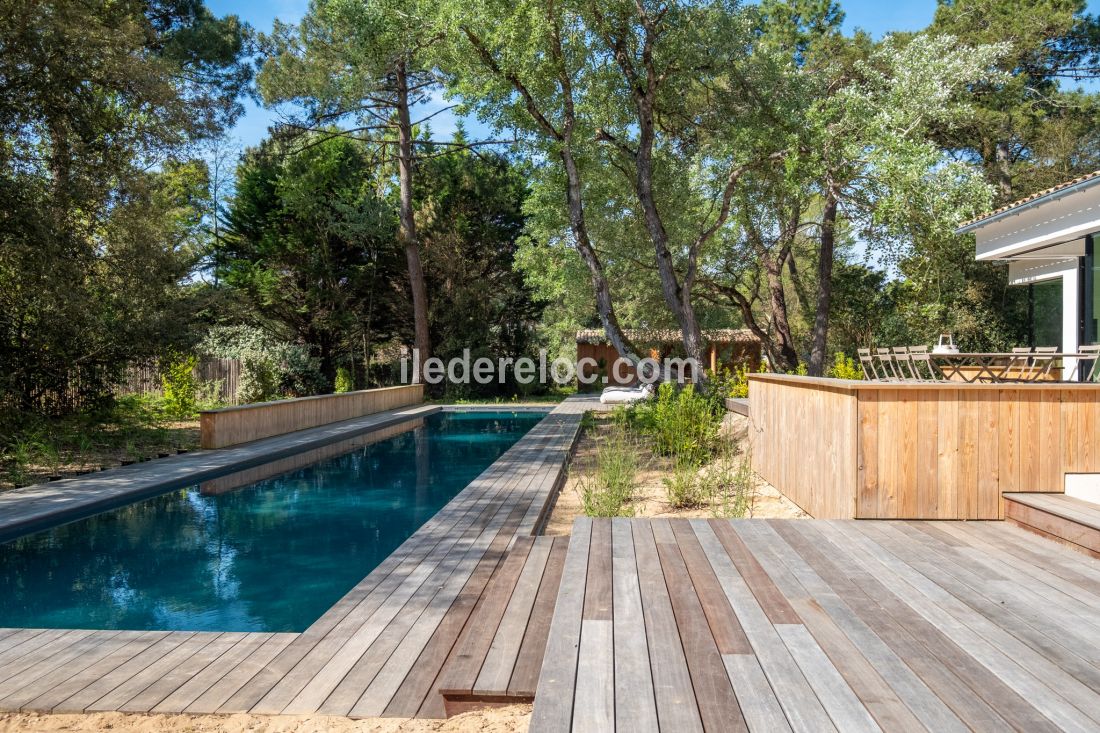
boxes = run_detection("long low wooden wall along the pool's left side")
[199,384,424,449]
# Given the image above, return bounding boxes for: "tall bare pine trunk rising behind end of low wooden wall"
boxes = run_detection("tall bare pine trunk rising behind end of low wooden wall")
[396,61,431,374]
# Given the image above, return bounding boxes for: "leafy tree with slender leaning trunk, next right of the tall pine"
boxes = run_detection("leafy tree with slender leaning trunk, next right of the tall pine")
[436,0,640,362]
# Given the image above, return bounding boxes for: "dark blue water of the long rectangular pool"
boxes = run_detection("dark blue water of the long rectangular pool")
[0,412,543,632]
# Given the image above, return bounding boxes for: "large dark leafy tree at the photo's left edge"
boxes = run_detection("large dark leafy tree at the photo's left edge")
[0,0,249,412]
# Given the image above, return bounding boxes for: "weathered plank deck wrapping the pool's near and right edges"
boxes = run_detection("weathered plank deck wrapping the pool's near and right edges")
[0,398,592,718]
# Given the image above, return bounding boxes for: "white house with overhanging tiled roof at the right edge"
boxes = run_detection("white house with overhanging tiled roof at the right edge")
[956,171,1100,367]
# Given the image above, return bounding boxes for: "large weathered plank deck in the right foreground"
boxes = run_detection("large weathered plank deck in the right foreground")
[530,512,1100,733]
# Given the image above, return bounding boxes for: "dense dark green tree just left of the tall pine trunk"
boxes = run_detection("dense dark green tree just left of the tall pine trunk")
[215,133,404,389]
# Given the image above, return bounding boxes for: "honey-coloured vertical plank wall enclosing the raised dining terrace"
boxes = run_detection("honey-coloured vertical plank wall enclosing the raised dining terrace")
[749,375,1100,519]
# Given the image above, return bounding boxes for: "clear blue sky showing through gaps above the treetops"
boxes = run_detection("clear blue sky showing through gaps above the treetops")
[207,0,1100,147]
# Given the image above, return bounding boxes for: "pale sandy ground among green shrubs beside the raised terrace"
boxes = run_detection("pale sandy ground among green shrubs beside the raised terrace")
[545,413,810,536]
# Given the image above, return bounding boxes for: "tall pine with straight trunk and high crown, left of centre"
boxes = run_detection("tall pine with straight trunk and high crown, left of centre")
[259,0,477,362]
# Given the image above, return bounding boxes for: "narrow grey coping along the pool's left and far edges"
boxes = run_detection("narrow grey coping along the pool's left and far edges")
[0,404,552,541]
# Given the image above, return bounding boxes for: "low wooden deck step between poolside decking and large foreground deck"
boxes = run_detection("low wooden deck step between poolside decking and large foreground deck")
[438,537,569,718]
